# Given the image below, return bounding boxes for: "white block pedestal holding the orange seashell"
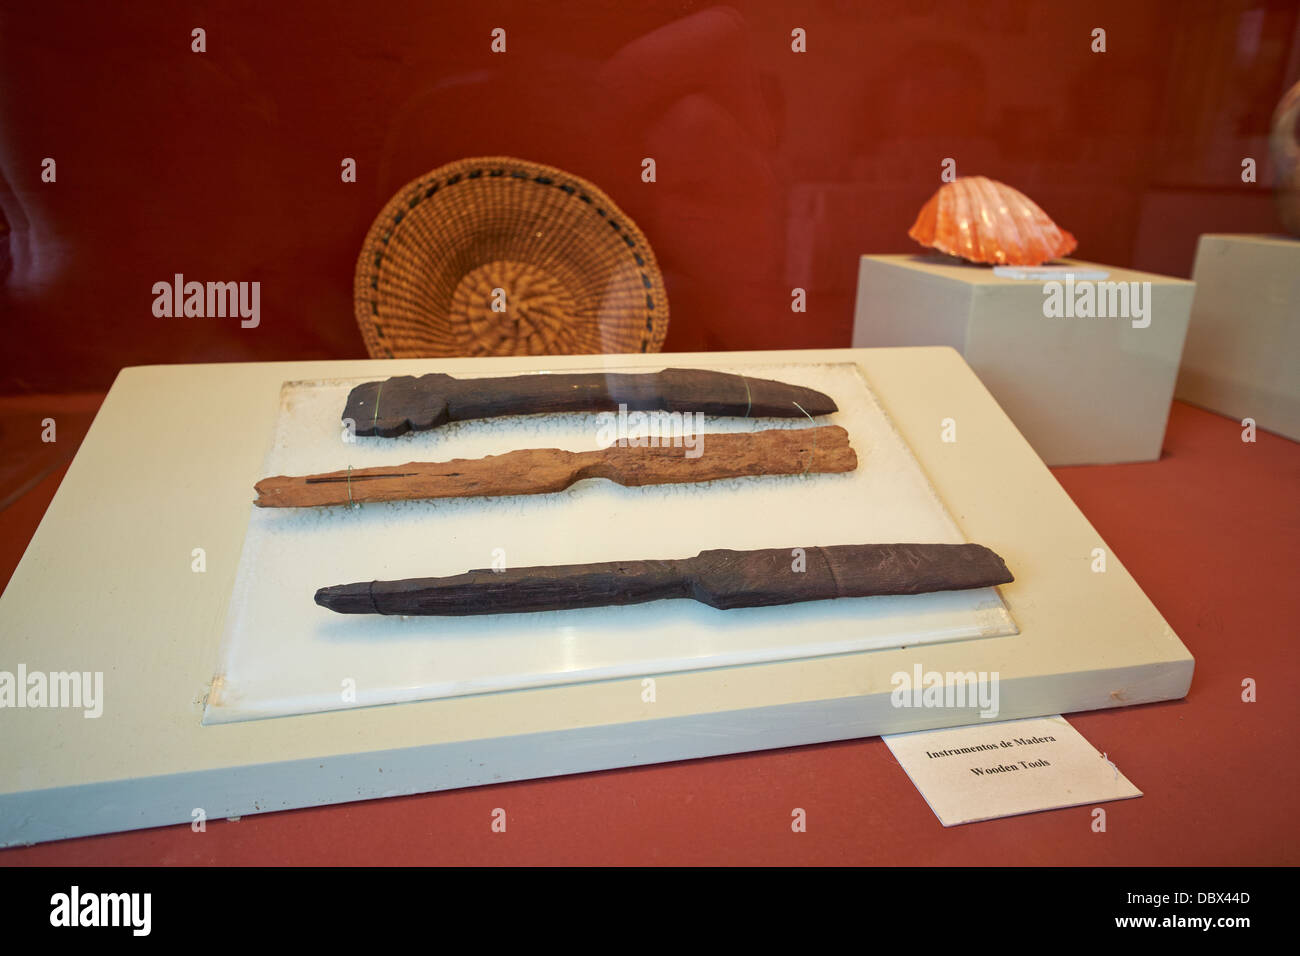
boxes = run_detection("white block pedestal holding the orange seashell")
[853,255,1193,464]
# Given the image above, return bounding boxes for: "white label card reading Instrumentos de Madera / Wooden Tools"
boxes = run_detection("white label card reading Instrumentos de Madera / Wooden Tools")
[883,717,1141,826]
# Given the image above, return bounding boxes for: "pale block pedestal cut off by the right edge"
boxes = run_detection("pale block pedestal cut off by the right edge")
[1175,234,1300,441]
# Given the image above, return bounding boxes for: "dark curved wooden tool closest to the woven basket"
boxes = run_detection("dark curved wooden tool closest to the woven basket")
[343,368,836,438]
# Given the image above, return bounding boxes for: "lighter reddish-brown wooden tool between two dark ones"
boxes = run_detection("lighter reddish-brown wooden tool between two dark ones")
[254,425,858,507]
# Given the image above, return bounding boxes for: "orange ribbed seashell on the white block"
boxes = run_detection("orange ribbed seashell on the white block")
[907,176,1079,265]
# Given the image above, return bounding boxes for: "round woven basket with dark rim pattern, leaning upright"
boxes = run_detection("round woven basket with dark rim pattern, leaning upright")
[354,156,668,358]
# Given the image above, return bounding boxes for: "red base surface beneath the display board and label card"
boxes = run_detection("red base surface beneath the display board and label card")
[0,403,1300,865]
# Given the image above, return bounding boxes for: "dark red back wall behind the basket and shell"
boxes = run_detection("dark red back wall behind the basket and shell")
[0,0,1300,392]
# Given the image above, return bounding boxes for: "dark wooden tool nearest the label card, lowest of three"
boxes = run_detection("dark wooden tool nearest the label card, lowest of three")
[316,544,1014,615]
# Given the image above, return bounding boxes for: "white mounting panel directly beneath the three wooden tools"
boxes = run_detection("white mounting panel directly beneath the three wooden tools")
[204,363,1015,723]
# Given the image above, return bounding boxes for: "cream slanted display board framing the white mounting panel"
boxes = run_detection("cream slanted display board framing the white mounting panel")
[0,349,1193,845]
